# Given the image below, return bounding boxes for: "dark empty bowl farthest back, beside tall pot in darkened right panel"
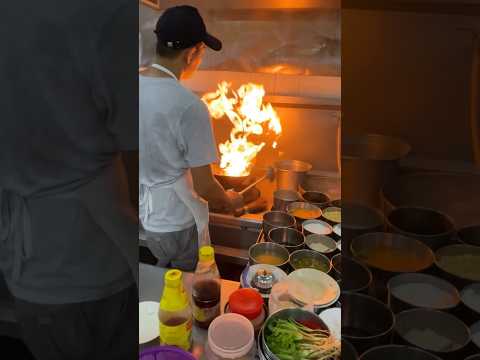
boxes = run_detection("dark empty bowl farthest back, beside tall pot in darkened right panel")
[387,206,455,251]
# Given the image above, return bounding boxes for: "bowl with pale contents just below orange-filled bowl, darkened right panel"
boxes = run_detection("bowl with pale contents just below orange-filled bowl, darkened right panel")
[387,273,460,313]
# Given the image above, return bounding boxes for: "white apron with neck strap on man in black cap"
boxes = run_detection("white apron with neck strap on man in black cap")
[140,64,210,247]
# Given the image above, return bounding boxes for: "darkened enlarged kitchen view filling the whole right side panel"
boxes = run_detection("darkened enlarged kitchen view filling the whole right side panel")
[342,0,480,360]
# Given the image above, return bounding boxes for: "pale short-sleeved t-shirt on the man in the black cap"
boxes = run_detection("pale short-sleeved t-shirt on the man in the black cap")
[139,75,218,232]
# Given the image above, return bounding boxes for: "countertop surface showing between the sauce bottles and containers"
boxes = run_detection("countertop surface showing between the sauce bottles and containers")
[139,263,253,360]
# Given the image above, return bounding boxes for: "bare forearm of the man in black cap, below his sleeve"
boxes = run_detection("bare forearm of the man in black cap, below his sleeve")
[191,164,234,213]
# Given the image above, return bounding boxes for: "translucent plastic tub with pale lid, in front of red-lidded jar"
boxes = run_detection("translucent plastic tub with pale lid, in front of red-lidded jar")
[205,313,255,360]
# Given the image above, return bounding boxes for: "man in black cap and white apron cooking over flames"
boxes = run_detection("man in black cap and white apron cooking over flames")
[139,6,239,271]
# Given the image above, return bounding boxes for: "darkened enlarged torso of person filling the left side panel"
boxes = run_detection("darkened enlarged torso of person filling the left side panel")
[0,0,138,360]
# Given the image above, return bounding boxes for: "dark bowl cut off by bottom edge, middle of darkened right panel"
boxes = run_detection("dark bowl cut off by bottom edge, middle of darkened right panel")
[360,345,442,360]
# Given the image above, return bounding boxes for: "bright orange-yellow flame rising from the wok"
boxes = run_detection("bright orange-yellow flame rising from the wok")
[202,81,282,176]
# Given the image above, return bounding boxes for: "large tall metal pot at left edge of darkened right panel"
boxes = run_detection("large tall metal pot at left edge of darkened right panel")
[342,134,410,209]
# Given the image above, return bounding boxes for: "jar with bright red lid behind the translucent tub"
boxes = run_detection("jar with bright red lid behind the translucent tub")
[226,289,266,333]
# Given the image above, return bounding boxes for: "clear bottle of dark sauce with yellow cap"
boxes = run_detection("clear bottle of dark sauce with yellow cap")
[192,246,221,329]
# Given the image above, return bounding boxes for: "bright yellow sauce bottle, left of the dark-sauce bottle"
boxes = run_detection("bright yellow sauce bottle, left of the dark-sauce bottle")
[158,270,192,351]
